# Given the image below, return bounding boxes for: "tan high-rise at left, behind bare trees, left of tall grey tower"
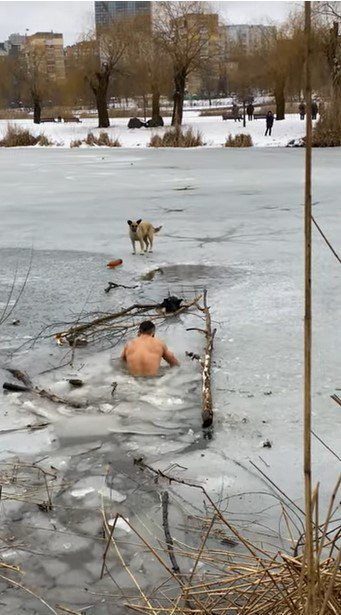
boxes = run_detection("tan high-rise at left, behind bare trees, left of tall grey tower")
[24,32,65,81]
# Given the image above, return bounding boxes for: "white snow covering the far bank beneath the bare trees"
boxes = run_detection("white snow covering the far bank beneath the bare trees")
[0,110,305,148]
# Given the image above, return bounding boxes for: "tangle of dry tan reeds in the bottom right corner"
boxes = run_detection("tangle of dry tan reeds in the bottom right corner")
[102,460,341,615]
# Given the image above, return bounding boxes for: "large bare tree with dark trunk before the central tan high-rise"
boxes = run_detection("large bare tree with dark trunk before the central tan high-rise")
[155,1,212,126]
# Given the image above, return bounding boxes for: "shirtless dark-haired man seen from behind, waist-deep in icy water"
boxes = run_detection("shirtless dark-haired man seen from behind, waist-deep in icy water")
[121,320,180,376]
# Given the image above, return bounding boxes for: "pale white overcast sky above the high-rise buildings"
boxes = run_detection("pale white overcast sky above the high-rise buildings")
[0,0,303,45]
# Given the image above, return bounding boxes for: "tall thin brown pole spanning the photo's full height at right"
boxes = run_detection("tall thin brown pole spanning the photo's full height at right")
[304,2,316,615]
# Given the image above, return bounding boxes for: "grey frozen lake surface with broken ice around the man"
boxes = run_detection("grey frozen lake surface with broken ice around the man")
[0,148,341,615]
